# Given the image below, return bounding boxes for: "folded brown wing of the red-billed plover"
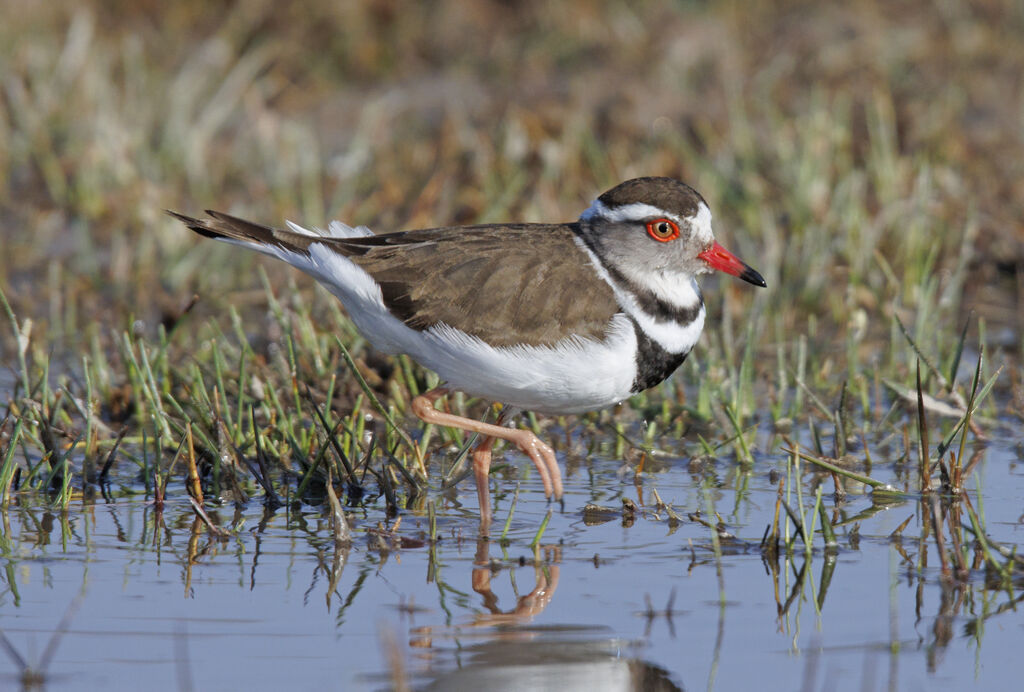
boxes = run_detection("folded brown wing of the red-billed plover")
[327,224,618,346]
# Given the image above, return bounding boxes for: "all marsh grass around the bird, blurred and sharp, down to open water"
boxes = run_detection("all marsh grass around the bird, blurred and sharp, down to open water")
[0,1,1024,686]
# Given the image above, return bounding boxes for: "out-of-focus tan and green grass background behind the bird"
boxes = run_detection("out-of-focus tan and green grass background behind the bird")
[0,0,1024,411]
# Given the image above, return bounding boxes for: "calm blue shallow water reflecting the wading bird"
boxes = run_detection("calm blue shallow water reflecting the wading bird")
[0,429,1024,692]
